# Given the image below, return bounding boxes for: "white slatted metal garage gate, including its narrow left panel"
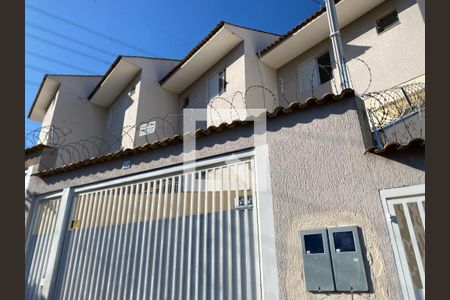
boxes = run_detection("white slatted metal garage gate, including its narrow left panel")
[26,159,261,299]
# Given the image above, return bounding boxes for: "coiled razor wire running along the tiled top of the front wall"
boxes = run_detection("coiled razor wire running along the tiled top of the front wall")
[25,58,408,168]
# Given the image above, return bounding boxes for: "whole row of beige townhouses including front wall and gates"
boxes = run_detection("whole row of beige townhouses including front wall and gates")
[25,0,425,299]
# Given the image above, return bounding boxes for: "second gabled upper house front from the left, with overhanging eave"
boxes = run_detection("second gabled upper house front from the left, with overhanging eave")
[89,56,179,151]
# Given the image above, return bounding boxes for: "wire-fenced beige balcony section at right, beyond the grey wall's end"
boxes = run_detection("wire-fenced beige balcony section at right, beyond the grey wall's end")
[361,82,425,149]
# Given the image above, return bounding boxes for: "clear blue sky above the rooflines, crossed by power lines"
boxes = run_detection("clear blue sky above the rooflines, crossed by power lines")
[25,0,320,132]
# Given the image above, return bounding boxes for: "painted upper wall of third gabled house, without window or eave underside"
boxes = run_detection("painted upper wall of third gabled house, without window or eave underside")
[180,24,278,126]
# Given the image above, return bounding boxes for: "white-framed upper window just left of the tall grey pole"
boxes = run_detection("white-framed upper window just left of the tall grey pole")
[298,51,333,93]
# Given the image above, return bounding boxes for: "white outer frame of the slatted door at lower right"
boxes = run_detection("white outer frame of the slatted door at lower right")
[379,184,425,299]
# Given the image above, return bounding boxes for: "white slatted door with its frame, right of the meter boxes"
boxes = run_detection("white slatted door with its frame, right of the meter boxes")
[381,185,425,299]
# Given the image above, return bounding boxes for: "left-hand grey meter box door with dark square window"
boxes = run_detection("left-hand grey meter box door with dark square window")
[300,229,335,292]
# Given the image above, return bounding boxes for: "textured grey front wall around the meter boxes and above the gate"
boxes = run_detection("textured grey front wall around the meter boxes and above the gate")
[26,98,425,299]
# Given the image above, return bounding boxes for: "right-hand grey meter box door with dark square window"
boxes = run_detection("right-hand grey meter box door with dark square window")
[328,226,369,292]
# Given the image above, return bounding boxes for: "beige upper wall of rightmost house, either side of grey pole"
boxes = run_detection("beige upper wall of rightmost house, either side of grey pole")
[277,0,425,103]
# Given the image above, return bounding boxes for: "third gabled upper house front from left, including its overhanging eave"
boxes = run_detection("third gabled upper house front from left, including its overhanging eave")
[160,22,279,126]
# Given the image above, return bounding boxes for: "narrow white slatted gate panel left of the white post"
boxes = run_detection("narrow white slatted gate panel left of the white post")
[25,197,61,299]
